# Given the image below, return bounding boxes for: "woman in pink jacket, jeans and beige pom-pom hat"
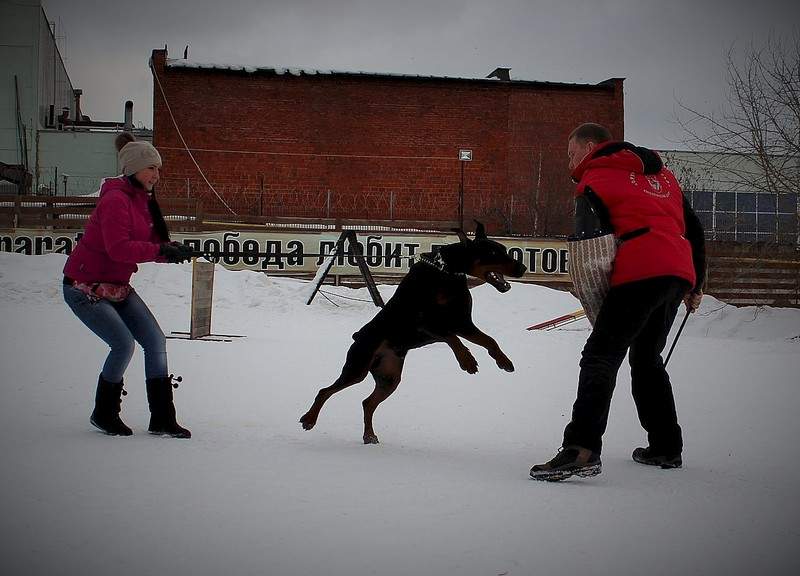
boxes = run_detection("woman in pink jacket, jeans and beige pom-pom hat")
[64,132,191,438]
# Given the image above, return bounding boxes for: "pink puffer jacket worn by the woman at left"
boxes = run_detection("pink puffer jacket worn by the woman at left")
[64,176,164,284]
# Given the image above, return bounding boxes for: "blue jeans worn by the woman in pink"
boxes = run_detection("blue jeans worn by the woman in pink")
[64,285,168,382]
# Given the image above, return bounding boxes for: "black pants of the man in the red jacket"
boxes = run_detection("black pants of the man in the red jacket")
[564,276,690,455]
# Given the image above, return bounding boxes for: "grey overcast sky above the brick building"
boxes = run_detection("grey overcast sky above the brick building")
[43,0,800,148]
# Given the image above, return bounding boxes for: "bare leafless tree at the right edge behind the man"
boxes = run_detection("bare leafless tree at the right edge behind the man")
[678,31,800,194]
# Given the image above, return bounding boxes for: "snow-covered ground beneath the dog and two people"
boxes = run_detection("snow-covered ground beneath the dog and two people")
[0,253,800,576]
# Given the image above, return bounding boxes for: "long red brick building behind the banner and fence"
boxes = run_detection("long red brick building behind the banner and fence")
[152,50,624,236]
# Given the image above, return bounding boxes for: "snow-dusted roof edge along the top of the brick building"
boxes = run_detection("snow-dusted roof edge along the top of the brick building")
[166,58,615,88]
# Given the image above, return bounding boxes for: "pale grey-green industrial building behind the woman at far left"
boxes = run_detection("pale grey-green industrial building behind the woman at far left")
[0,0,152,196]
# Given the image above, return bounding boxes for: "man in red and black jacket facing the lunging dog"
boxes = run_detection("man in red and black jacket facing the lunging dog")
[531,124,705,481]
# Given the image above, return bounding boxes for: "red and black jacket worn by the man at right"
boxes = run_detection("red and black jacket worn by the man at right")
[572,142,705,290]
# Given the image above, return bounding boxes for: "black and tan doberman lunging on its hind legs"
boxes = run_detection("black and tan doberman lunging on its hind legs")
[300,223,526,444]
